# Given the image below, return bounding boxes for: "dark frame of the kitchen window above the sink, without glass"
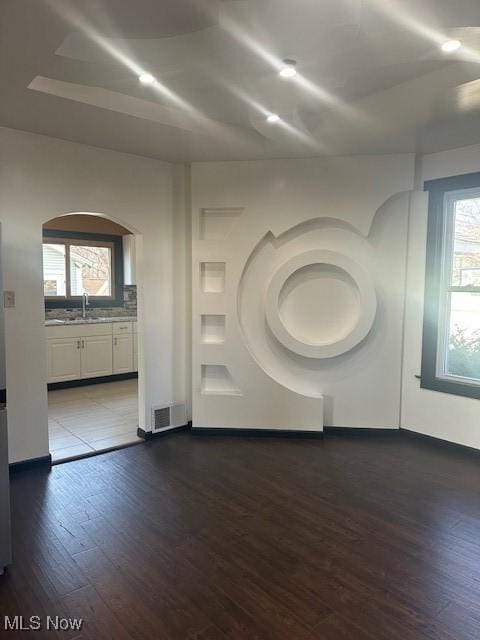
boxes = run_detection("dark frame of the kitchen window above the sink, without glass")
[42,229,124,309]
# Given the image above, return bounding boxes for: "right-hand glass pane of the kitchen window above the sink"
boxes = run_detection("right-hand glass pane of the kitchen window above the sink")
[70,245,112,296]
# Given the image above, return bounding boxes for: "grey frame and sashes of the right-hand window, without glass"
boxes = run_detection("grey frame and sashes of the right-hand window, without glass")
[420,172,480,399]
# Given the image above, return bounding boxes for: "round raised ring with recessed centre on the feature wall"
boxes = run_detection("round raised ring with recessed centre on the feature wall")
[265,250,377,358]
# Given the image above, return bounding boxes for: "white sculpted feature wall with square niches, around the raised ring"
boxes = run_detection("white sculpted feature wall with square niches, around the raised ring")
[192,154,415,429]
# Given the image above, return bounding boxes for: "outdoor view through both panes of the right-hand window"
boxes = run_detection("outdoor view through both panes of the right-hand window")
[445,196,480,380]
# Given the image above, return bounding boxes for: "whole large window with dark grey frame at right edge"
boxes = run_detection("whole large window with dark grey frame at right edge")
[421,174,480,398]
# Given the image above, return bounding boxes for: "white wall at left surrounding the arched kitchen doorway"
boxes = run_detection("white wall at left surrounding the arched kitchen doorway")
[0,129,186,462]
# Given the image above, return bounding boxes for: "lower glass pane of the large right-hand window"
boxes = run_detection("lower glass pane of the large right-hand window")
[445,292,480,380]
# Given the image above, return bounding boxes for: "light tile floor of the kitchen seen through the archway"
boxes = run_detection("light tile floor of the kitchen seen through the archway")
[48,380,142,462]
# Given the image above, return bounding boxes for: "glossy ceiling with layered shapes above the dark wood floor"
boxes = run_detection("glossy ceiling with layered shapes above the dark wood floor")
[0,0,480,162]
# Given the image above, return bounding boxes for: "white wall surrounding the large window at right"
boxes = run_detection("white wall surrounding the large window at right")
[401,145,480,448]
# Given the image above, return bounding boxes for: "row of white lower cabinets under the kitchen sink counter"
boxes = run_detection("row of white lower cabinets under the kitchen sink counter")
[47,322,137,382]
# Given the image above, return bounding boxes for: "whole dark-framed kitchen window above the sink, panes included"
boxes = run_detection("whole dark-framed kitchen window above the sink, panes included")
[43,230,123,307]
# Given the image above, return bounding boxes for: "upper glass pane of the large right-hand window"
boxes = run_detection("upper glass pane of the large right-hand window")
[452,197,480,287]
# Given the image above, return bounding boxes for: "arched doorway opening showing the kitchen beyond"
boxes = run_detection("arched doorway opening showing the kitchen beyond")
[43,213,142,463]
